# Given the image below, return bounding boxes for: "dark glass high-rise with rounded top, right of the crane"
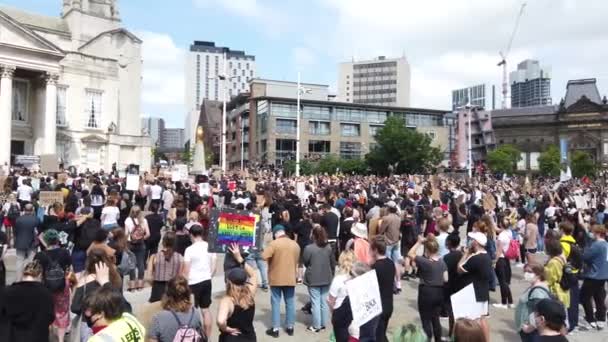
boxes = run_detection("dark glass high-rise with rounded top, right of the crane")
[510,59,551,108]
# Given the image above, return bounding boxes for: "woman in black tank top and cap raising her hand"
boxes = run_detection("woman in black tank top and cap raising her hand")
[217,245,257,342]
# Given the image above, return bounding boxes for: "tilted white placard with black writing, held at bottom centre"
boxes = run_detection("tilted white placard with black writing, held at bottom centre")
[346,270,382,327]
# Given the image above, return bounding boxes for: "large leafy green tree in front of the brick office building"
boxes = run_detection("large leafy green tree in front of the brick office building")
[365,116,442,175]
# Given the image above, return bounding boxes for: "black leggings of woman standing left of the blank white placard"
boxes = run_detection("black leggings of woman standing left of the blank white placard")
[418,285,443,342]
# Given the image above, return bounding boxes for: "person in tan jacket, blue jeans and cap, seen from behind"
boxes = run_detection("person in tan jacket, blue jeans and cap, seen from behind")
[262,224,300,338]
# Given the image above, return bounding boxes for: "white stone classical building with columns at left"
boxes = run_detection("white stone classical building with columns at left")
[0,0,151,172]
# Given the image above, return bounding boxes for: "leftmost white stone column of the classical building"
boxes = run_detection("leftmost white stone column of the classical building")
[0,65,15,171]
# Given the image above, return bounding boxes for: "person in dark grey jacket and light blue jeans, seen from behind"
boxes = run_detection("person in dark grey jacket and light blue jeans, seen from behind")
[302,225,336,332]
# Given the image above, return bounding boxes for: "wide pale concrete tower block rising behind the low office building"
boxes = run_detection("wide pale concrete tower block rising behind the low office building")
[338,56,411,107]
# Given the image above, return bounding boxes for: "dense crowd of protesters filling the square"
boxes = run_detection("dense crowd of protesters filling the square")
[0,170,608,342]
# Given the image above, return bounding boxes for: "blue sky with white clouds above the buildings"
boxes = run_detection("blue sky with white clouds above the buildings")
[2,0,608,127]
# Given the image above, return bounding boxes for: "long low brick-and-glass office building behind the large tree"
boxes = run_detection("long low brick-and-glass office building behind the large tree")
[226,79,452,168]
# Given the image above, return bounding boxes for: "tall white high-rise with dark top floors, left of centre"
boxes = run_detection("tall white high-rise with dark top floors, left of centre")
[185,41,255,112]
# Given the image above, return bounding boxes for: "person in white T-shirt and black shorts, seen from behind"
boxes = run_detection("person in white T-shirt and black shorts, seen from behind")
[184,225,217,338]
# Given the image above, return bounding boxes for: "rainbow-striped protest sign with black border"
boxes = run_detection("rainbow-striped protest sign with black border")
[209,209,262,253]
